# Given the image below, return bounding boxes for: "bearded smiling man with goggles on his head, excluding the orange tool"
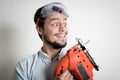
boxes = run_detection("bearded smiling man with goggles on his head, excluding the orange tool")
[15,2,73,80]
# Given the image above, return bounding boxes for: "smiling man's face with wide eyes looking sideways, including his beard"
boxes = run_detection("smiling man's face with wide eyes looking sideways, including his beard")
[42,14,68,49]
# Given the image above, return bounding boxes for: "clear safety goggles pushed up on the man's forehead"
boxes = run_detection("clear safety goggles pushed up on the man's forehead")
[41,2,69,18]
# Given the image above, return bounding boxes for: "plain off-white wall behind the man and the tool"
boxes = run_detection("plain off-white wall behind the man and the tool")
[0,0,120,80]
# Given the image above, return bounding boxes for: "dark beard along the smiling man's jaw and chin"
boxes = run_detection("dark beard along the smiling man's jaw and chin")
[44,35,67,49]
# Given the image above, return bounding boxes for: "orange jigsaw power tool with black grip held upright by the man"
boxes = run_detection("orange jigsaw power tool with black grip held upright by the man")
[55,38,99,80]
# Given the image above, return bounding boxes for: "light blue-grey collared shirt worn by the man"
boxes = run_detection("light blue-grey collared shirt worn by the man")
[14,49,66,80]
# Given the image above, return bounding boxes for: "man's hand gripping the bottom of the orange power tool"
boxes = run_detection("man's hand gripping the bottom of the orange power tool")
[52,70,73,80]
